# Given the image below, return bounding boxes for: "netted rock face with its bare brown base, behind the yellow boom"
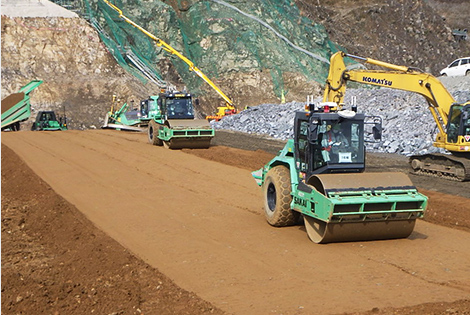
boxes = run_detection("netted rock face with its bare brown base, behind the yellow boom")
[92,0,330,113]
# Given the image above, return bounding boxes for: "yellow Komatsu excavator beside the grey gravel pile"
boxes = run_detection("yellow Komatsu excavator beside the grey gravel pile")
[323,52,470,181]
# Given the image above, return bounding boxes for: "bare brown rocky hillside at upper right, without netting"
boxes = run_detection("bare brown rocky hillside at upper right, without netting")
[295,0,470,76]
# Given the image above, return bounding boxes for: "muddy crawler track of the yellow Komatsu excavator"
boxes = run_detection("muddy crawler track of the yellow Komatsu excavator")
[409,154,470,182]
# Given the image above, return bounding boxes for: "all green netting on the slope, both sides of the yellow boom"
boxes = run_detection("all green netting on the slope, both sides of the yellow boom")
[79,0,346,96]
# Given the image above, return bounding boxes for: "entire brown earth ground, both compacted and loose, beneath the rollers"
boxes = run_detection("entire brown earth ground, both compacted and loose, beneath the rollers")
[1,130,470,314]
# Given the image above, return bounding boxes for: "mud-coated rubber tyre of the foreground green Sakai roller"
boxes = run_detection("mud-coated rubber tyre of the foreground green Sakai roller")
[263,165,300,227]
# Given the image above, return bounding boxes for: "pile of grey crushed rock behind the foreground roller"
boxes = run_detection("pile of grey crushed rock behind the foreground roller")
[211,77,470,155]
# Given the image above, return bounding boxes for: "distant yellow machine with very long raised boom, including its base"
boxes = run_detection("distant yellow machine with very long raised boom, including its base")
[103,0,238,120]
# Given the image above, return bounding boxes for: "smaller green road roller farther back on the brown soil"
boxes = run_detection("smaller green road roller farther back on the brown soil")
[147,91,215,149]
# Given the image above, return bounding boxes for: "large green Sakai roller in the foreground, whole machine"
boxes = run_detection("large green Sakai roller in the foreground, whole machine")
[253,103,427,243]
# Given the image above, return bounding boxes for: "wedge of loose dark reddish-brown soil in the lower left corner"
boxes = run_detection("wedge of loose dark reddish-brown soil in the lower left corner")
[2,145,223,314]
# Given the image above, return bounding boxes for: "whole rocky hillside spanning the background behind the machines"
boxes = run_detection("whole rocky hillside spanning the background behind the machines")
[1,0,470,129]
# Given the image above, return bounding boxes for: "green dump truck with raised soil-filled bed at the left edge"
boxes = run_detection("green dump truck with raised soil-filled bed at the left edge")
[2,80,43,131]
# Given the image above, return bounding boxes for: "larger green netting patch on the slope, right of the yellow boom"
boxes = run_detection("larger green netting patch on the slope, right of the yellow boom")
[181,0,342,96]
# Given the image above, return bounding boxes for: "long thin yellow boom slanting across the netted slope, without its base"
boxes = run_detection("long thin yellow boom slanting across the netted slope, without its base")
[103,0,235,109]
